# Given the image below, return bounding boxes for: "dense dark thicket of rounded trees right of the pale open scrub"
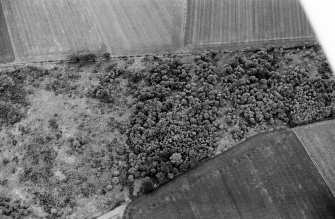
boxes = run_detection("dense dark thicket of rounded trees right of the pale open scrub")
[128,47,335,187]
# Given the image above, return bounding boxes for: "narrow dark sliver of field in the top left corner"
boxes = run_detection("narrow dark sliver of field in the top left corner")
[0,2,15,63]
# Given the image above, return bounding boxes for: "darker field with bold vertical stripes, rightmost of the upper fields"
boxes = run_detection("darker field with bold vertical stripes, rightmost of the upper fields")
[184,0,313,47]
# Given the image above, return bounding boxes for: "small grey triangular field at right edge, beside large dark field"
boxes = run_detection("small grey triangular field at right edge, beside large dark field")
[294,120,335,195]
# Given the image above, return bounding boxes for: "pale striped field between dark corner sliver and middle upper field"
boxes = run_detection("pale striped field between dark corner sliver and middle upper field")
[1,0,103,61]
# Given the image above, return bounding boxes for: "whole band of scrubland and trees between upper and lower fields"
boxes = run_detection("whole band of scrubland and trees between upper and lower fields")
[0,45,335,219]
